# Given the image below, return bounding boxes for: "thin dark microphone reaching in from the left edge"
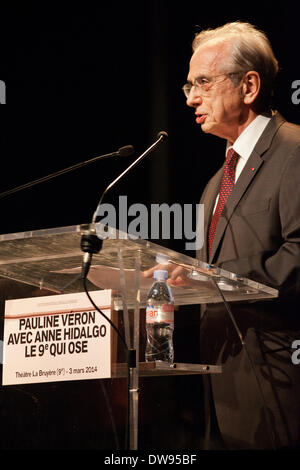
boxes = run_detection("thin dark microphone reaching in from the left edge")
[0,145,134,199]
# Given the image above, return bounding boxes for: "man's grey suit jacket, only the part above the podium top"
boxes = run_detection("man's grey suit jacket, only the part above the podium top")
[199,113,300,294]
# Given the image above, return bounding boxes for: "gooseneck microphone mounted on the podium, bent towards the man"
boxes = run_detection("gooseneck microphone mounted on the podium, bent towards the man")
[81,131,168,279]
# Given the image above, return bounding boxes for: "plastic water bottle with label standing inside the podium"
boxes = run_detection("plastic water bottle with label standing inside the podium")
[145,270,174,363]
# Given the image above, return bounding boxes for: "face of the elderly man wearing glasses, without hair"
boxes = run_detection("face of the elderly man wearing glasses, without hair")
[187,43,247,142]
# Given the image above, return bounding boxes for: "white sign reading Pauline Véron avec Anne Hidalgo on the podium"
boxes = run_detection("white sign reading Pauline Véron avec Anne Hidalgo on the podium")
[2,290,111,385]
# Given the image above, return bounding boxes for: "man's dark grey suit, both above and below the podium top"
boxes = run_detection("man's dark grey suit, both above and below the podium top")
[198,113,300,449]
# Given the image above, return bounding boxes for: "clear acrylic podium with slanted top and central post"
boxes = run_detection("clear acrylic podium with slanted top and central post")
[0,224,277,450]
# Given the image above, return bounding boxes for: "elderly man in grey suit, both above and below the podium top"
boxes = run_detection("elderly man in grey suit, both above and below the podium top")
[180,22,300,449]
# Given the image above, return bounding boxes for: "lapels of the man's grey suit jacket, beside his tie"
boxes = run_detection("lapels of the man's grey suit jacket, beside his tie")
[205,113,284,263]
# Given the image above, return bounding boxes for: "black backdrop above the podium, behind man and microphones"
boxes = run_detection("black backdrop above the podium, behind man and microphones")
[0,0,300,254]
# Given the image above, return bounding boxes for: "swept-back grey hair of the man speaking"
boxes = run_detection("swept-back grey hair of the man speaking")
[192,21,278,112]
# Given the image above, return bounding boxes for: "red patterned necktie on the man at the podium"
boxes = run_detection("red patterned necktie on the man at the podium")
[208,148,239,253]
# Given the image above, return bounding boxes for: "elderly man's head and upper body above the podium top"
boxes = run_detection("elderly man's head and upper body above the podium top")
[184,23,300,292]
